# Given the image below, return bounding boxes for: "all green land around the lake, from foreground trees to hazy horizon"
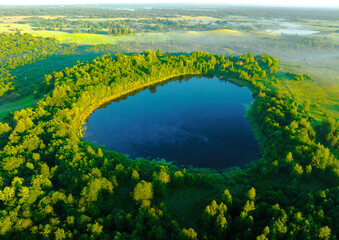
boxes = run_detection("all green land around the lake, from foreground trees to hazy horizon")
[0,6,339,240]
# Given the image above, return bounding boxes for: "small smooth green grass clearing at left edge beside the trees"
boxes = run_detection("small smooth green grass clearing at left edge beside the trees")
[0,96,39,121]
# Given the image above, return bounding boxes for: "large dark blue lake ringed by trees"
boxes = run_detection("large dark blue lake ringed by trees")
[84,77,259,168]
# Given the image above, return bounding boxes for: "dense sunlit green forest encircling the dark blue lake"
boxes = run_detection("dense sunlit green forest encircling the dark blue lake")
[0,29,339,240]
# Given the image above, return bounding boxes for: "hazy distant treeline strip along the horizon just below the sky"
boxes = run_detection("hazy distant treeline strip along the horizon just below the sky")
[0,5,339,21]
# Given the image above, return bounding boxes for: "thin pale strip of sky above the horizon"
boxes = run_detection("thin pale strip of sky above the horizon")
[0,0,339,8]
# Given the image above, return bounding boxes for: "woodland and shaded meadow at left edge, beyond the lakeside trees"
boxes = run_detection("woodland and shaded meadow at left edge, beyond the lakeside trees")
[0,32,119,122]
